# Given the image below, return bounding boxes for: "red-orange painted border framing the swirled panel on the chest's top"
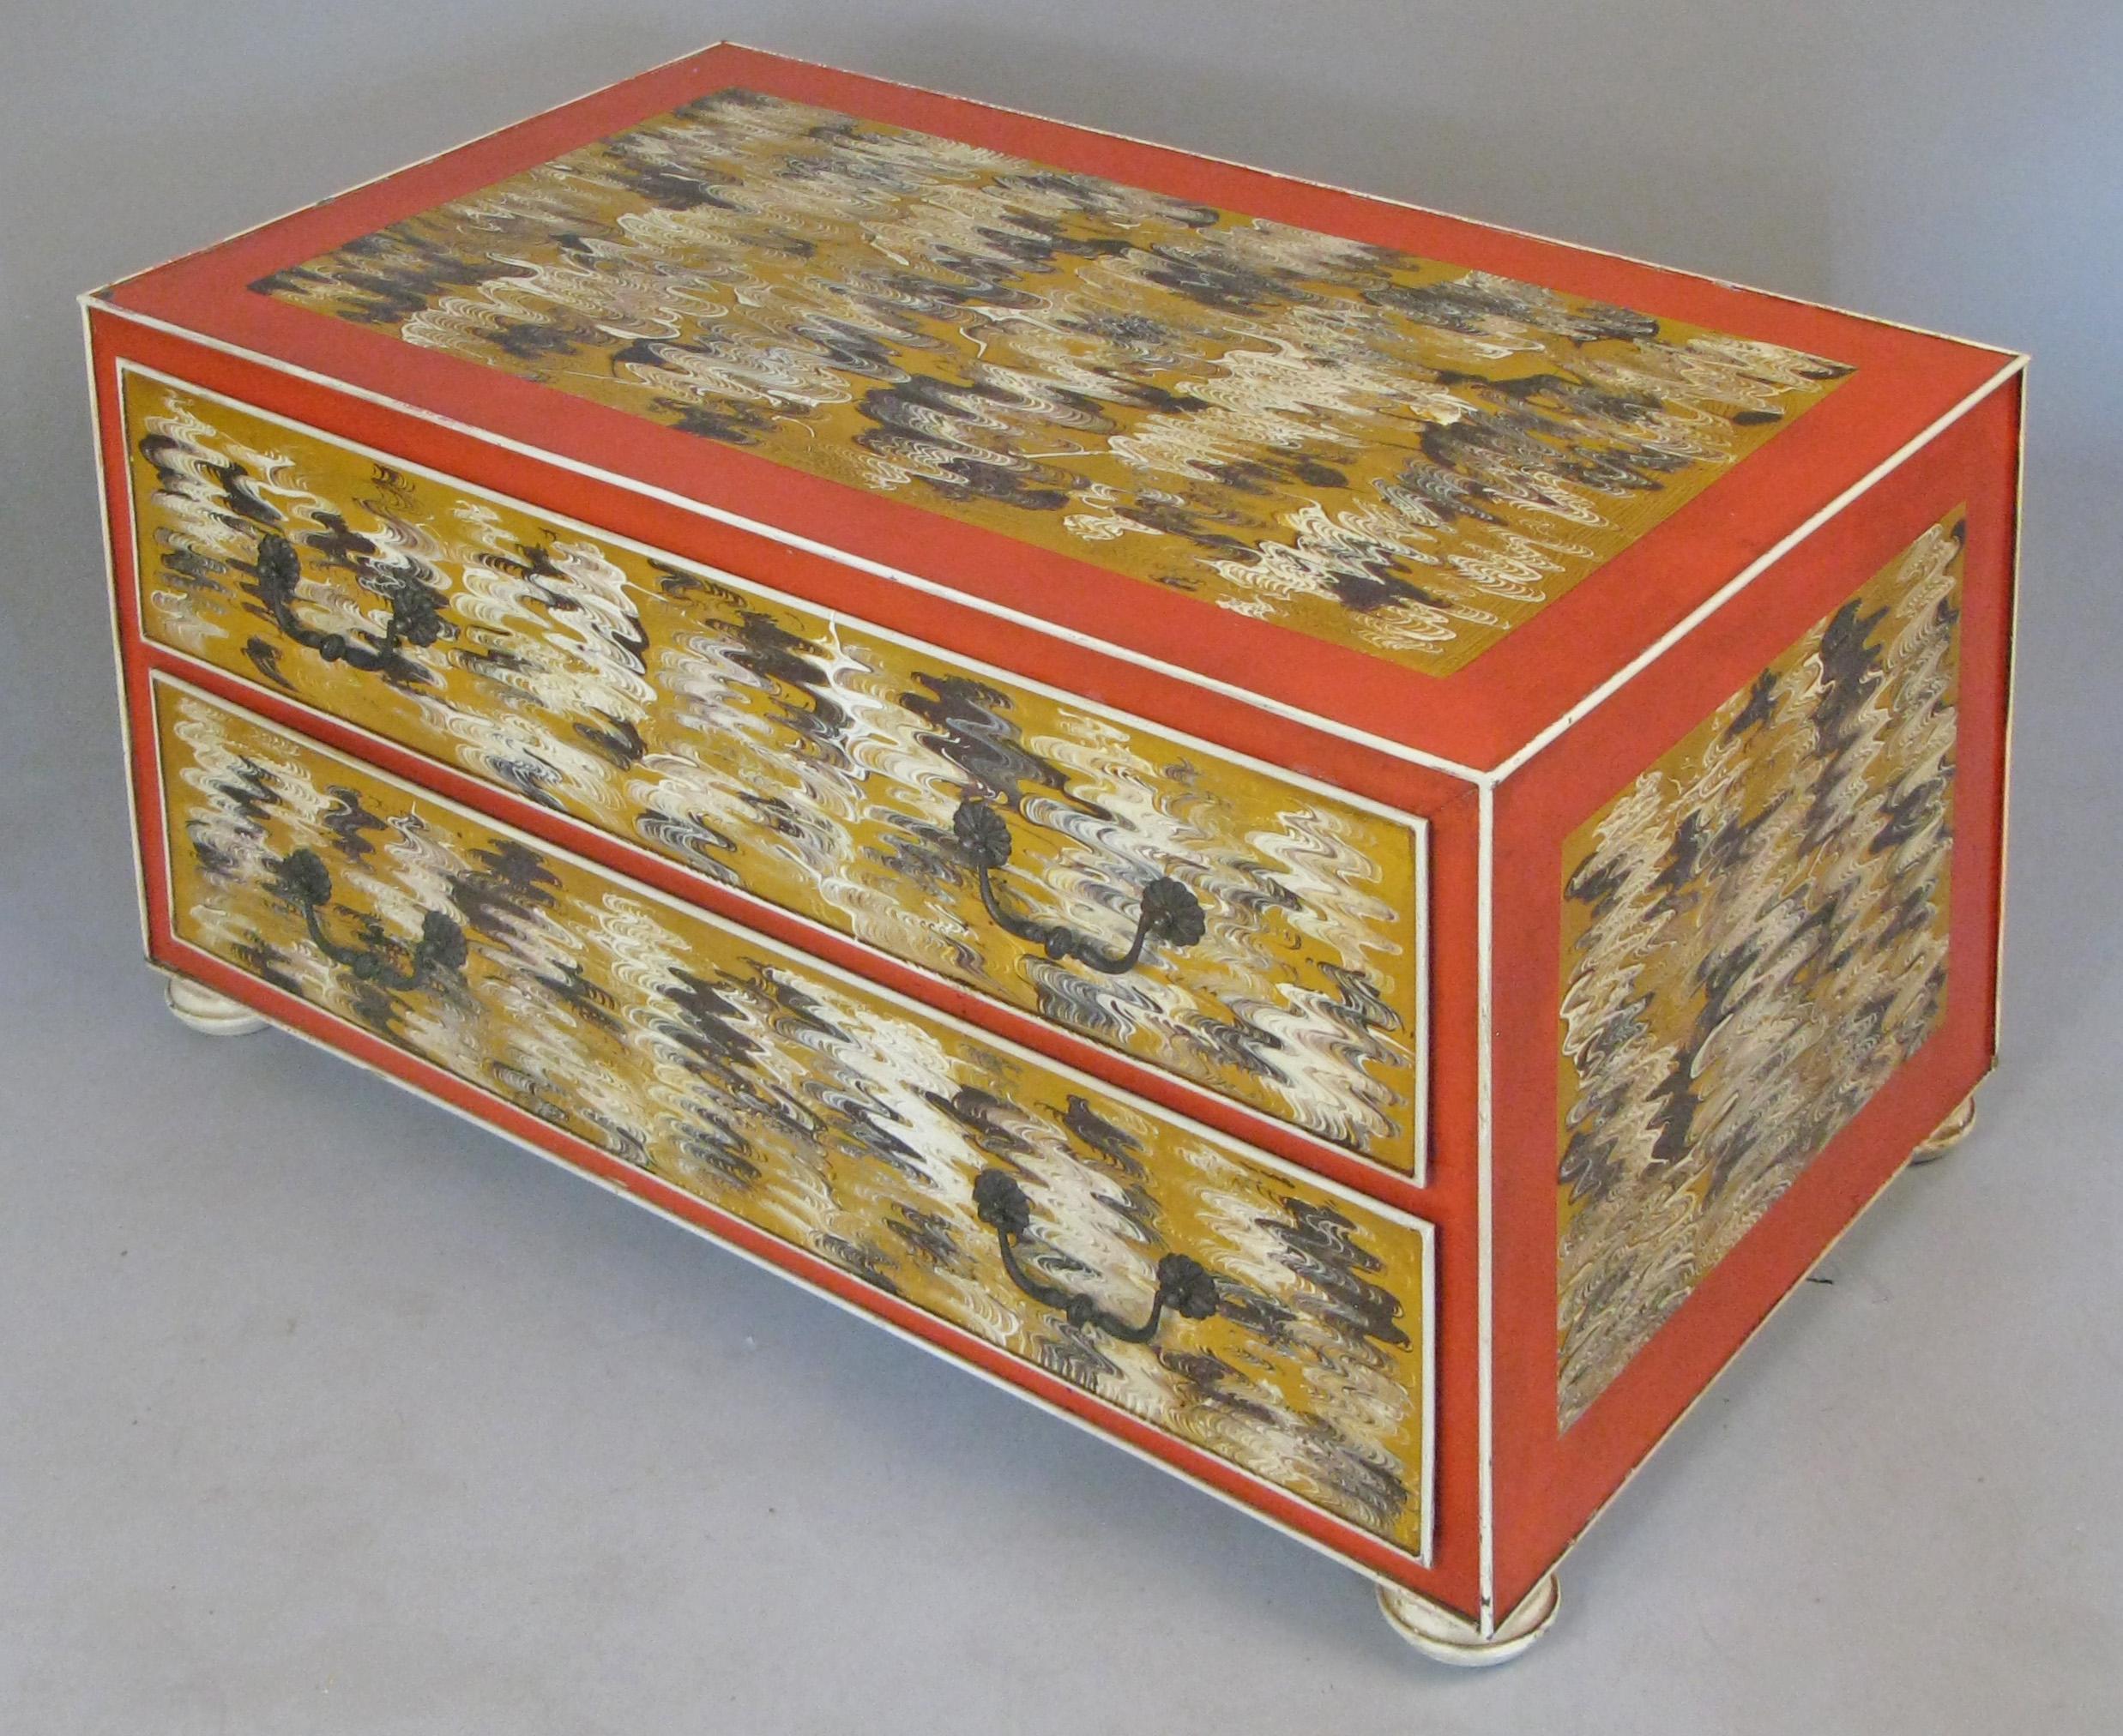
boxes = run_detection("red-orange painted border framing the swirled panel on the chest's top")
[102,45,2004,770]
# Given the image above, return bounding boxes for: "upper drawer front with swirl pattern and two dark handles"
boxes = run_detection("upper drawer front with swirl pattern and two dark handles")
[121,365,1426,1172]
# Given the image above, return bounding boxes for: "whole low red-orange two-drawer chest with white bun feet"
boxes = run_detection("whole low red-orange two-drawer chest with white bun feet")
[85,45,2023,1661]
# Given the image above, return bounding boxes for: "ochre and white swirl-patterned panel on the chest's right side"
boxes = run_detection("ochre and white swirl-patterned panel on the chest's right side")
[1556,511,1966,1428]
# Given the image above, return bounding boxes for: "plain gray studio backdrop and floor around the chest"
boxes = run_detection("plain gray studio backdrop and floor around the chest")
[0,0,2123,1736]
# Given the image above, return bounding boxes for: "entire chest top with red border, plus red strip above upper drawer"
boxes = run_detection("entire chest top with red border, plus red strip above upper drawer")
[103,42,2019,763]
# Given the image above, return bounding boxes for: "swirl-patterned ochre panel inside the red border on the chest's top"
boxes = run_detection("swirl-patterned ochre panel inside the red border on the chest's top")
[253,87,1851,675]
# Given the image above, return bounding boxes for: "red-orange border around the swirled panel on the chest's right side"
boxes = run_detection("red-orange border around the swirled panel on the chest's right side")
[1493,382,2021,1609]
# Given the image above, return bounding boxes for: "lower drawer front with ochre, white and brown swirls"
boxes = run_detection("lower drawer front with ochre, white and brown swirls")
[155,679,1431,1556]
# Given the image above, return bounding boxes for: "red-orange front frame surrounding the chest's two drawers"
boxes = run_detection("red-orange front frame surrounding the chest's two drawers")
[89,310,1480,1612]
